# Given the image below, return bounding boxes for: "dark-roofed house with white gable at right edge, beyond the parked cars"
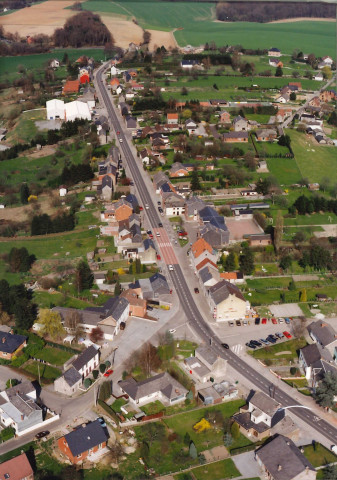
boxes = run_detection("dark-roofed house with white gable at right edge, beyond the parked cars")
[299,343,337,388]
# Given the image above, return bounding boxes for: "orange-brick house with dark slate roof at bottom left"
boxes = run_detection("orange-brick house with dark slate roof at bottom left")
[57,420,109,465]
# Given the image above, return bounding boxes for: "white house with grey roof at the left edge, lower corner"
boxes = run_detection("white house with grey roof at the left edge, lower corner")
[0,381,43,436]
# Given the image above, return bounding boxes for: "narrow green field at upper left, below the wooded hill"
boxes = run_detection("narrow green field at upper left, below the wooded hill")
[0,48,104,80]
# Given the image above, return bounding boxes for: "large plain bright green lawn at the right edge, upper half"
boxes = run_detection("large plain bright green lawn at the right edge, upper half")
[287,130,337,183]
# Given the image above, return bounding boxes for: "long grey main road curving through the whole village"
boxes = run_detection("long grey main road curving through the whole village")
[96,65,337,444]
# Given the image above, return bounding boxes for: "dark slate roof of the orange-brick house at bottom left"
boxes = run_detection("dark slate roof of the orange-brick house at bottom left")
[64,420,109,457]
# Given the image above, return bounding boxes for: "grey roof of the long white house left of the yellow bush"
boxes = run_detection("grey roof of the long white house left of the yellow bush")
[119,372,188,400]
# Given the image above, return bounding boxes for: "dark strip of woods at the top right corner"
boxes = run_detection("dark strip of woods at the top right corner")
[216,2,336,23]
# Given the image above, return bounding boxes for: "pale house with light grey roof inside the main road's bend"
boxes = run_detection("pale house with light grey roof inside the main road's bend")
[184,346,227,383]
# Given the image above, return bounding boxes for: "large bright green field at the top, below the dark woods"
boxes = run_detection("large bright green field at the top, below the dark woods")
[82,0,336,56]
